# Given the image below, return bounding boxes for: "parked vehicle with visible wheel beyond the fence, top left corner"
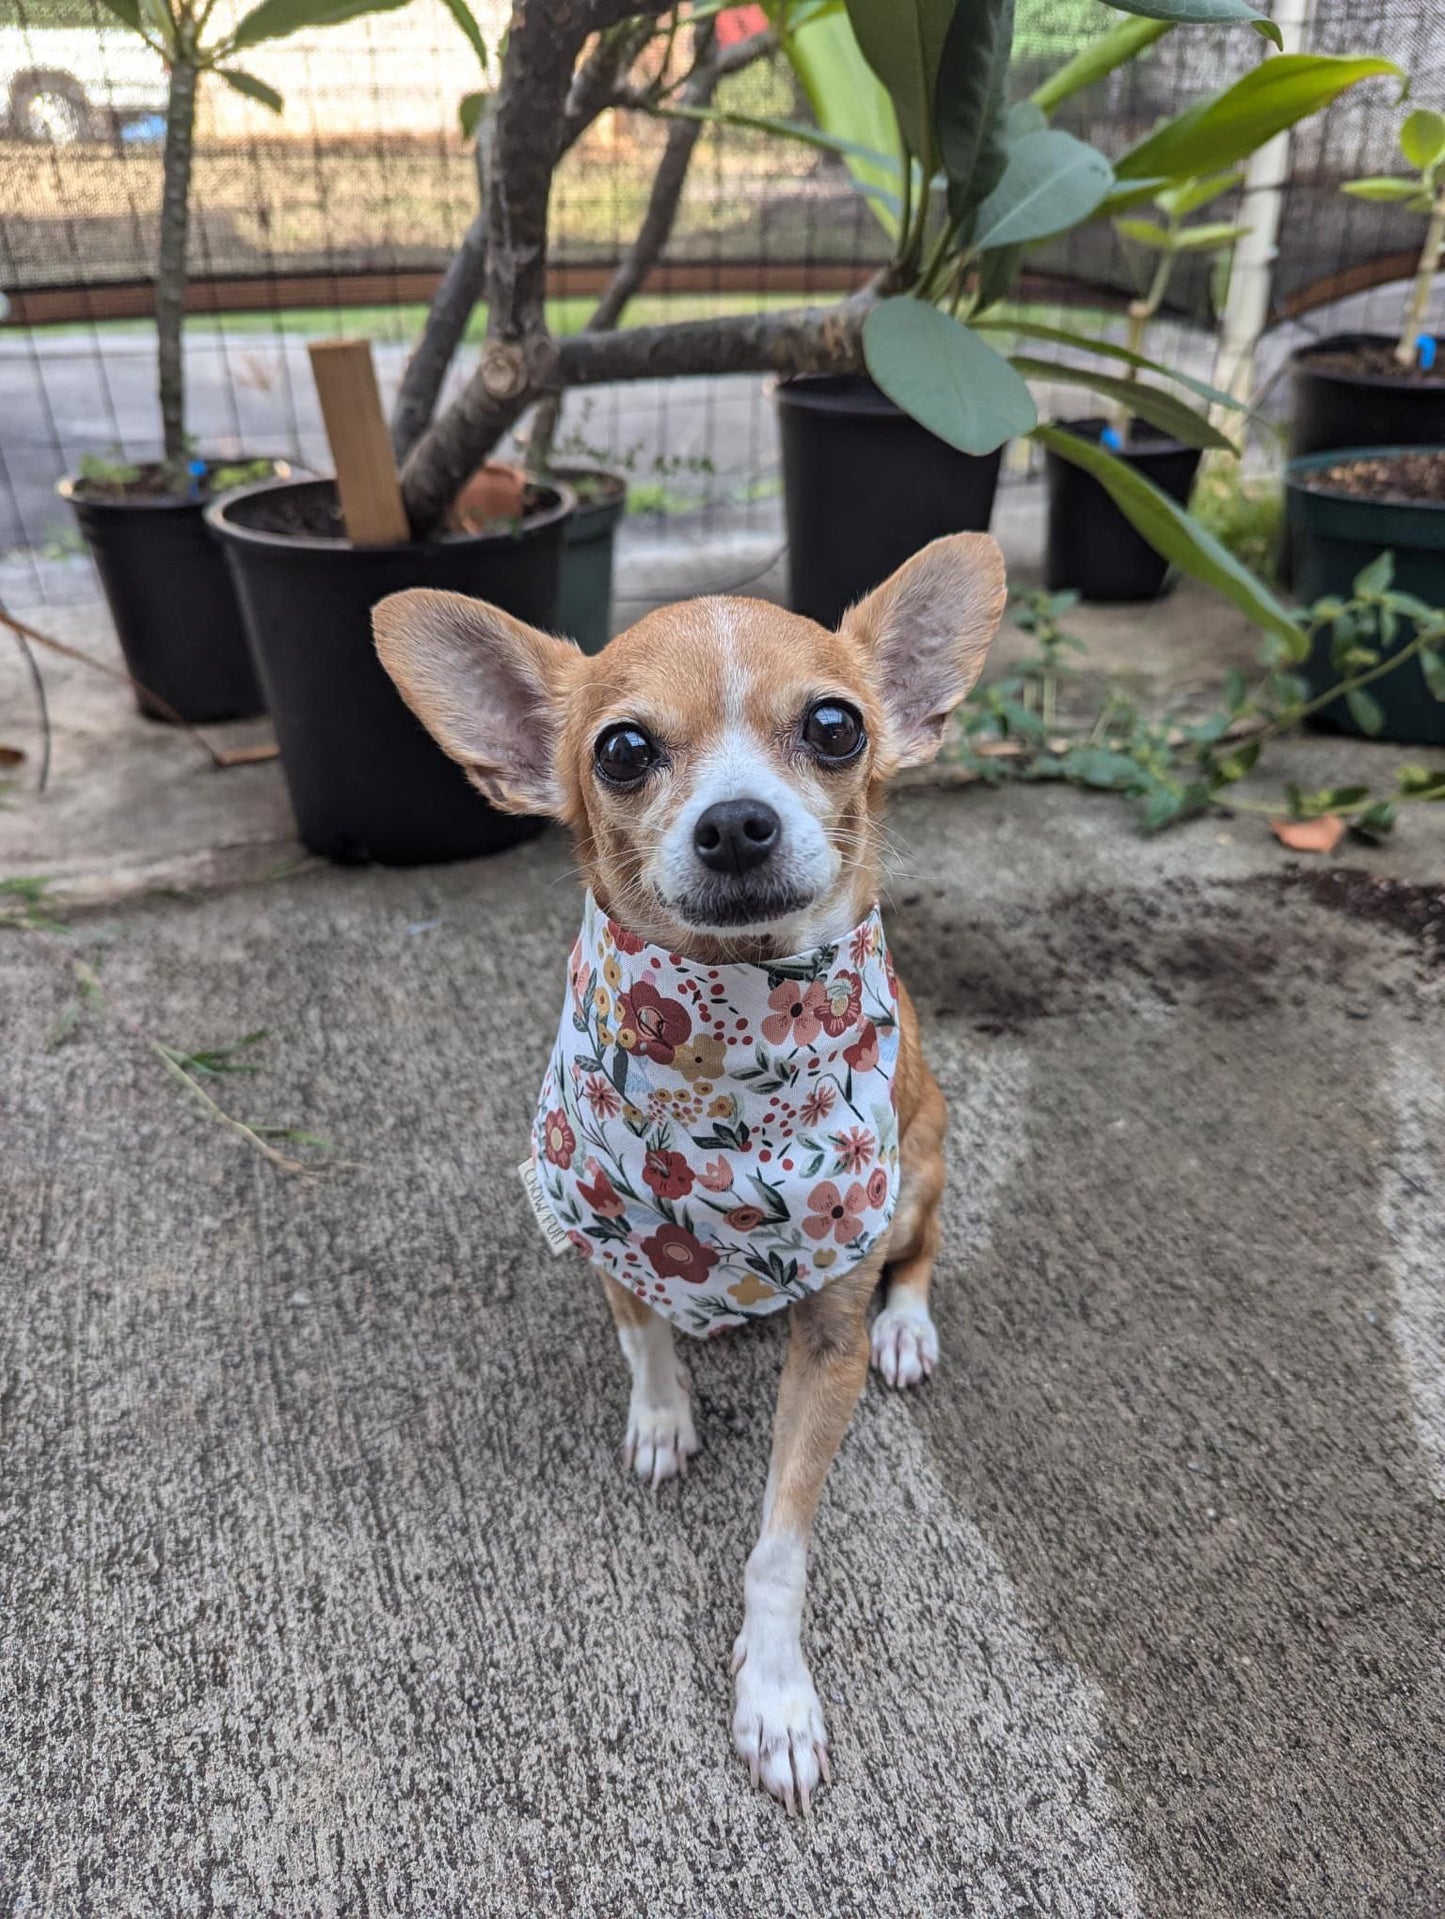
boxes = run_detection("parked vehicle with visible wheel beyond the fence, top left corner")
[0,0,167,146]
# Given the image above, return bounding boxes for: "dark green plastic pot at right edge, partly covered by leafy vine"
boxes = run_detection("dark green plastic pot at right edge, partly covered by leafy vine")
[1284,445,1445,746]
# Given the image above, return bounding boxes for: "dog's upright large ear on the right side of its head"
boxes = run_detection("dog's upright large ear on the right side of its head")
[842,533,1006,768]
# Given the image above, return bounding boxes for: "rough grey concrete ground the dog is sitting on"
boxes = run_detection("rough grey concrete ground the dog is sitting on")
[0,533,1445,1919]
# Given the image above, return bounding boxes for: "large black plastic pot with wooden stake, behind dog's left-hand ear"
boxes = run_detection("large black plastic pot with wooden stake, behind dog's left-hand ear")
[207,480,572,865]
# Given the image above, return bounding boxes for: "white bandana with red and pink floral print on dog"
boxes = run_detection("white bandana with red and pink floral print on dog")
[520,894,898,1334]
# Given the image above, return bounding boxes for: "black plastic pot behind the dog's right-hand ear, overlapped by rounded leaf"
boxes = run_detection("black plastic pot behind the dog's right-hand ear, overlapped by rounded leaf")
[775,374,1004,628]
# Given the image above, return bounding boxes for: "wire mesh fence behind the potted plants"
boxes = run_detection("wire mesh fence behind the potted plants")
[0,0,1445,593]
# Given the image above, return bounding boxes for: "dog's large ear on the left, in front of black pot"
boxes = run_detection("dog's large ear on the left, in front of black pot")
[372,587,581,817]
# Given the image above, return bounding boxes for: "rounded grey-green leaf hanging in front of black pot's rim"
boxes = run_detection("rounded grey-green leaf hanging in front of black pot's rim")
[864,294,1038,453]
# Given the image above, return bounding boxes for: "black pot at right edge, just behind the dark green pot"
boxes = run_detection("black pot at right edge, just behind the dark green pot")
[1290,334,1445,459]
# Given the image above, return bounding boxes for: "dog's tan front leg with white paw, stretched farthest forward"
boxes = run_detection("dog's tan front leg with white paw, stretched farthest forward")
[733,1259,881,1812]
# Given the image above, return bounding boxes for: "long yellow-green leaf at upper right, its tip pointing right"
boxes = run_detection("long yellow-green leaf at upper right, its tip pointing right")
[1113,54,1403,180]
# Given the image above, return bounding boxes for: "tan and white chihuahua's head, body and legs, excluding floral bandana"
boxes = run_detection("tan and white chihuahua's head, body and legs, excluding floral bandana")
[374,533,1004,1812]
